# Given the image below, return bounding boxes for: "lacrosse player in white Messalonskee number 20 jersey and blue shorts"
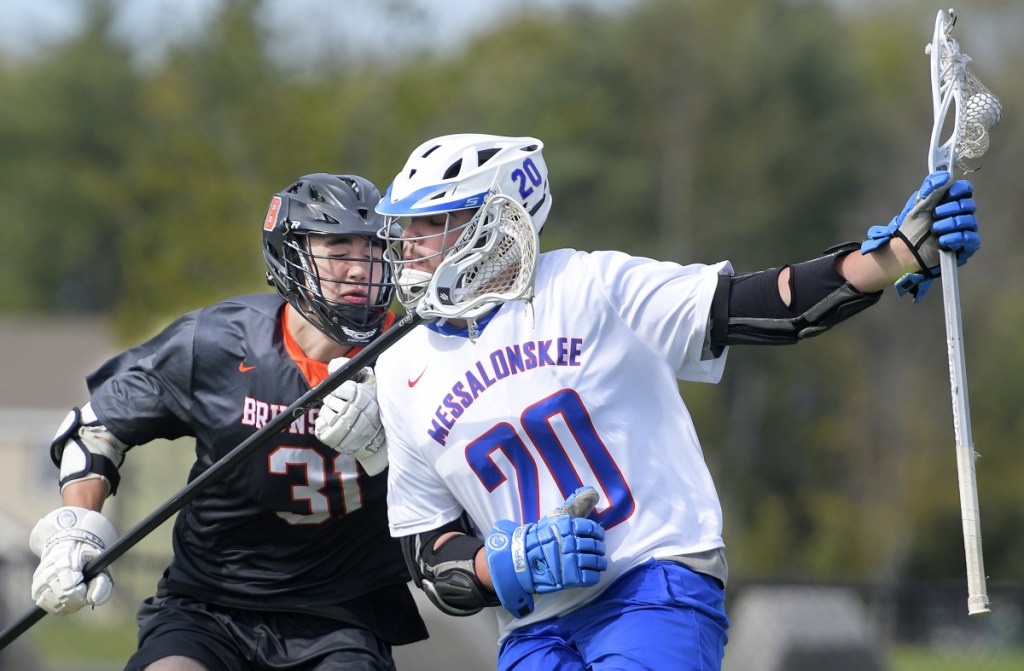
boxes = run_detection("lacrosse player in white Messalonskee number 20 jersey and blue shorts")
[318,134,980,671]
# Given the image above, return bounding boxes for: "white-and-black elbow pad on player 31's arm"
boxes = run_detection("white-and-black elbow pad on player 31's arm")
[50,404,128,496]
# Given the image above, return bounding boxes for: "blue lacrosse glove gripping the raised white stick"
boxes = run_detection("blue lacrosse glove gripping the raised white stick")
[860,170,981,303]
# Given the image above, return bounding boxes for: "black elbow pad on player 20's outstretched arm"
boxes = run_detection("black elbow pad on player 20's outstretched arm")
[711,243,883,355]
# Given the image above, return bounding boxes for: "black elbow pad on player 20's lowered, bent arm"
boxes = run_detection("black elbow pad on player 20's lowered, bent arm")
[399,522,501,616]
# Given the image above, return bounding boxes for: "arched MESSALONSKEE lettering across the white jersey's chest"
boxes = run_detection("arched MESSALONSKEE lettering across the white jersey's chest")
[427,338,583,446]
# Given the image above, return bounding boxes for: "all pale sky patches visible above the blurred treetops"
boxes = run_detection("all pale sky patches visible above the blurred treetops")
[0,0,1007,76]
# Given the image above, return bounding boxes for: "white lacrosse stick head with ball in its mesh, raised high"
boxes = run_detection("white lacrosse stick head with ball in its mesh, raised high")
[925,9,1002,173]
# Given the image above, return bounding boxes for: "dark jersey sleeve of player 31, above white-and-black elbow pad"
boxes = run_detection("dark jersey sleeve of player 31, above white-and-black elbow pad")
[86,312,197,446]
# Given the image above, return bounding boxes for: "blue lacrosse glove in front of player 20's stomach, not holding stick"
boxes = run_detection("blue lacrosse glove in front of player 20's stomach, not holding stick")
[484,487,608,618]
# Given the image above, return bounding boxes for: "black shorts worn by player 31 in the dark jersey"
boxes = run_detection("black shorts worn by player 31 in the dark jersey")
[125,596,395,671]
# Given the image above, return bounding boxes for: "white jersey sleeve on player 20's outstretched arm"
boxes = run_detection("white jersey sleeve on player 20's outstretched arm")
[588,252,732,382]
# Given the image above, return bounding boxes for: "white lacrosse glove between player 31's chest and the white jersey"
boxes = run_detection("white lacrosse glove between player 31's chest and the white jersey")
[314,357,387,475]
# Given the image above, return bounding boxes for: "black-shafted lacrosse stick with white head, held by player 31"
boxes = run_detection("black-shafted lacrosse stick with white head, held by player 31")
[0,191,538,651]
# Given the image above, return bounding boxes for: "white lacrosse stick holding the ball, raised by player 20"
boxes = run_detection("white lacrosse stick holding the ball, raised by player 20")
[925,9,1002,615]
